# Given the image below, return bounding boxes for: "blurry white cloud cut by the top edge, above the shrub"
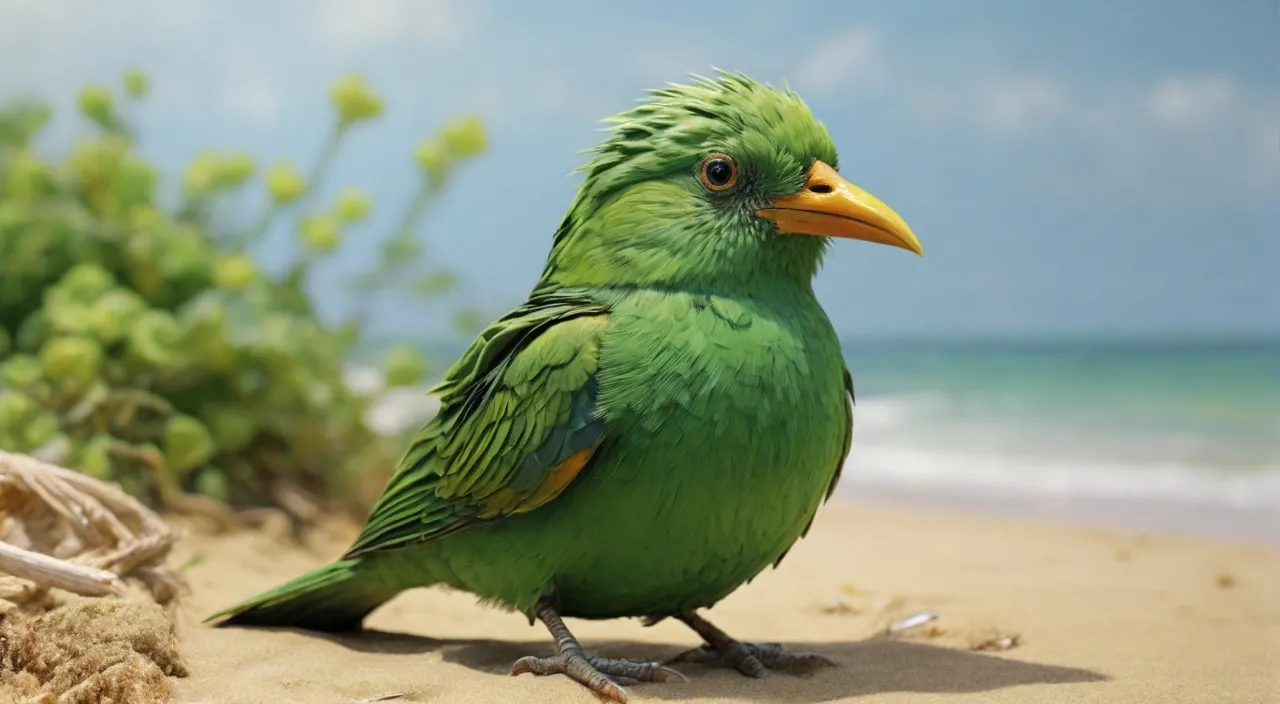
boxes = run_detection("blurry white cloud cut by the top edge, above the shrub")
[314,0,477,51]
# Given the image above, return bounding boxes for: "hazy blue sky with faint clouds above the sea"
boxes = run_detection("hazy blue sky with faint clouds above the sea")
[0,0,1280,337]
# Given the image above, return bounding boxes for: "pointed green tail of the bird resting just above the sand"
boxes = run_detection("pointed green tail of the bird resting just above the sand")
[205,558,401,632]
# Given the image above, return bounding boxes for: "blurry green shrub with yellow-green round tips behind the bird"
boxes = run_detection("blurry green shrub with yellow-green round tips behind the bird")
[0,72,486,519]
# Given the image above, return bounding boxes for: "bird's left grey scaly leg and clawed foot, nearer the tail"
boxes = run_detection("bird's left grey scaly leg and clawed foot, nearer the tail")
[511,599,689,703]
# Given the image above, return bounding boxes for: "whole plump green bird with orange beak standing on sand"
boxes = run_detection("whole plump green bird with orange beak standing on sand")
[210,73,923,701]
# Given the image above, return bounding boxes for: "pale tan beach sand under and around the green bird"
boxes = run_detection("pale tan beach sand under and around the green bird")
[170,500,1280,704]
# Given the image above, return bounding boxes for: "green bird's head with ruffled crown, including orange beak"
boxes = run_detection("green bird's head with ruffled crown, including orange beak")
[543,73,923,294]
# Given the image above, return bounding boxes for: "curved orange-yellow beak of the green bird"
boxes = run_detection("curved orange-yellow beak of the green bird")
[755,161,924,256]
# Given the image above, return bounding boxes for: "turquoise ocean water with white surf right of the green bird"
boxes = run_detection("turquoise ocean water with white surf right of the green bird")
[845,340,1280,511]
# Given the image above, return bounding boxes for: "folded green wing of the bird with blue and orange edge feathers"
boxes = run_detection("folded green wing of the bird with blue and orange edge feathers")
[344,293,608,557]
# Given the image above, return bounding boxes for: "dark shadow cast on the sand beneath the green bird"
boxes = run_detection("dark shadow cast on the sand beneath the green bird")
[324,630,1108,701]
